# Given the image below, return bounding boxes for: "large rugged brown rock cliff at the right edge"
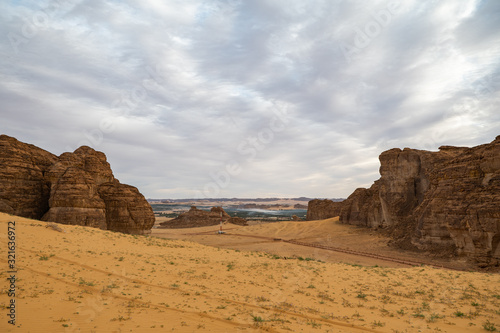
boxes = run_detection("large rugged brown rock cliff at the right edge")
[340,136,500,266]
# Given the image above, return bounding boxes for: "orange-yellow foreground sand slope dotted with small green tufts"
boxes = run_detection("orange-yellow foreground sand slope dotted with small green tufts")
[0,214,500,332]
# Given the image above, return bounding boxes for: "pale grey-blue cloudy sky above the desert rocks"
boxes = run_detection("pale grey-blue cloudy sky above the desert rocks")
[0,0,500,199]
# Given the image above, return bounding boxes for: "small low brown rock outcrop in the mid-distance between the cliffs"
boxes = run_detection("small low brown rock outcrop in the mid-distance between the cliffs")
[160,206,247,228]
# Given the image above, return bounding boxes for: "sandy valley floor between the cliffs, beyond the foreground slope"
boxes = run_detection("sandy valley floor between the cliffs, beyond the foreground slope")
[153,217,468,270]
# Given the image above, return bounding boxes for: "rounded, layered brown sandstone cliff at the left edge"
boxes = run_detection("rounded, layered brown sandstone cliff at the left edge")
[0,135,155,234]
